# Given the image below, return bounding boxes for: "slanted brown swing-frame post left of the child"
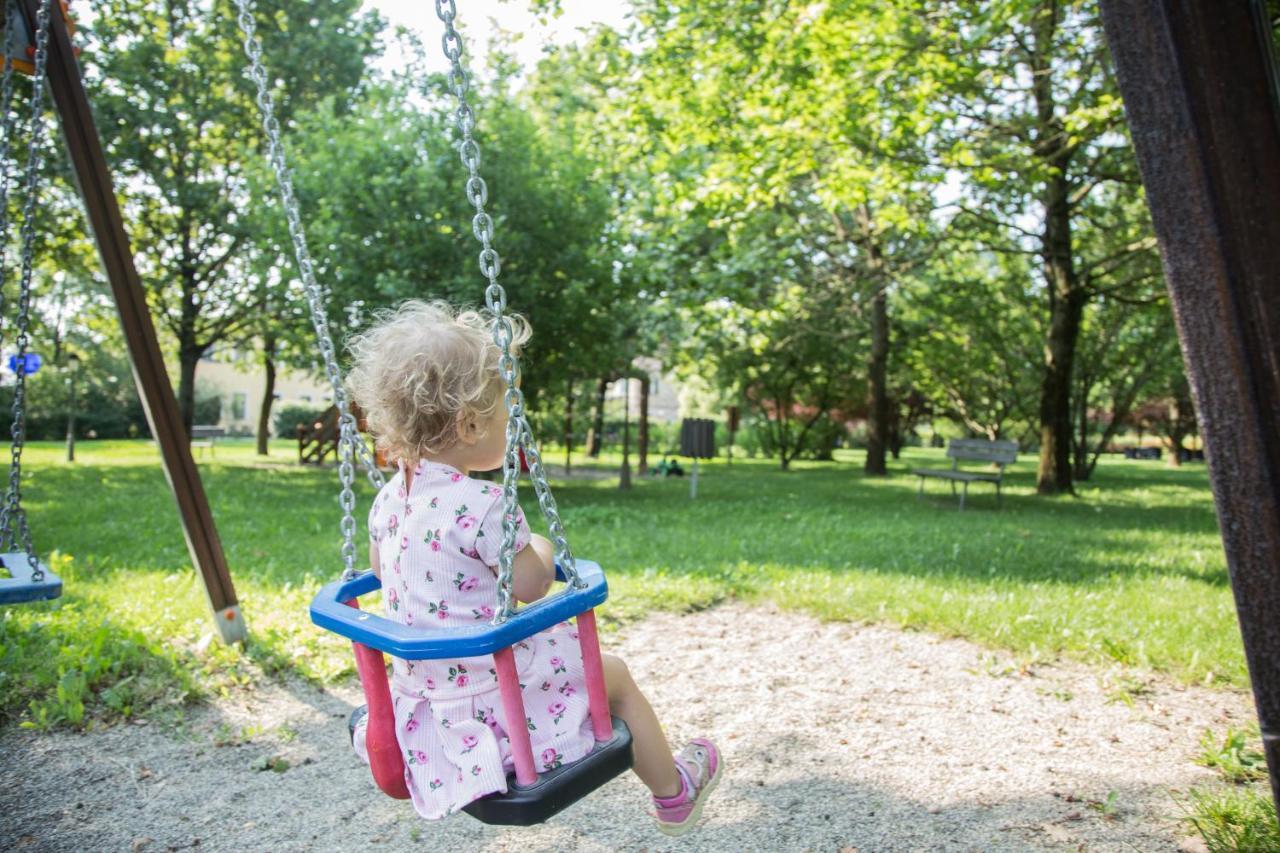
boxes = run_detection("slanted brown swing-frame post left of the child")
[19,0,244,643]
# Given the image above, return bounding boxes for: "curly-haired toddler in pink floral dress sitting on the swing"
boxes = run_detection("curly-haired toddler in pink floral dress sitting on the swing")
[348,301,723,835]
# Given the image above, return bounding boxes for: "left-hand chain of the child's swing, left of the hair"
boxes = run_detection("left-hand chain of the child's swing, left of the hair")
[236,0,384,579]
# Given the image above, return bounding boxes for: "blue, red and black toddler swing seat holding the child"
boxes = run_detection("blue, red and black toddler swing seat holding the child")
[311,560,632,826]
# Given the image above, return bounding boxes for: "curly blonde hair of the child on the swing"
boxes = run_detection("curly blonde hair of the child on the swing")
[347,300,530,462]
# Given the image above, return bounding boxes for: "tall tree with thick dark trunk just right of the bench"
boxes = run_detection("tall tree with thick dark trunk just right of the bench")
[920,0,1158,494]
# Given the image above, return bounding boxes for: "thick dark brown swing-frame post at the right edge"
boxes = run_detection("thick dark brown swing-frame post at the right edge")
[1102,0,1280,806]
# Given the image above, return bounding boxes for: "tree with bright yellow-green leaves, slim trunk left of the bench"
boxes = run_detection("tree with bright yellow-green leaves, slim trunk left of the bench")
[614,0,936,474]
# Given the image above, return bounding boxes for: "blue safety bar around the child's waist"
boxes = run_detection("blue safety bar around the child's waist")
[311,560,609,661]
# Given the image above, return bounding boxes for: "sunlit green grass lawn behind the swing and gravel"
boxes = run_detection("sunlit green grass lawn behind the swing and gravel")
[0,442,1247,726]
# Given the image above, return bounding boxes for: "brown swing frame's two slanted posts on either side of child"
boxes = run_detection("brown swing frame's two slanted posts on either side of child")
[0,0,1280,814]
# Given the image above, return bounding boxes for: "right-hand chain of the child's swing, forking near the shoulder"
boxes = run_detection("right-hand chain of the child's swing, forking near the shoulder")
[435,0,586,625]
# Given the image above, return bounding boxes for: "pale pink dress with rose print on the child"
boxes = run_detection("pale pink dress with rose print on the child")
[366,461,595,820]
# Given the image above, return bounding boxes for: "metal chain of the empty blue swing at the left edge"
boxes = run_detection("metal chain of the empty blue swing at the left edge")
[0,0,52,583]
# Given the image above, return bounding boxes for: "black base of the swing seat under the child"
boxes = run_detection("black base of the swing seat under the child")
[462,717,634,826]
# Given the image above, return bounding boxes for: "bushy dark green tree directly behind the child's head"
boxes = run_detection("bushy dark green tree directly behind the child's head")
[276,68,631,406]
